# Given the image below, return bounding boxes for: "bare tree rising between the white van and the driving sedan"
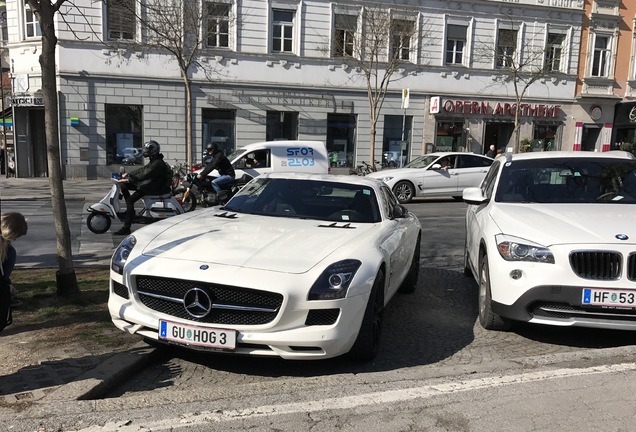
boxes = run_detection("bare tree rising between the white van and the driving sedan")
[323,6,422,166]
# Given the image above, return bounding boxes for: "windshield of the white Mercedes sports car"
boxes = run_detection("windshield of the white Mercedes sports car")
[224,178,381,223]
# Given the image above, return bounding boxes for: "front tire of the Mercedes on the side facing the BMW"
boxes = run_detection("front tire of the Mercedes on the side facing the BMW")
[349,270,384,361]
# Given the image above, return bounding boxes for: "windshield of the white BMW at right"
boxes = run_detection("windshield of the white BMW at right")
[495,157,636,204]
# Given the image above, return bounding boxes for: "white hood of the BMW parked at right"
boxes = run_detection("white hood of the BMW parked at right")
[490,204,636,246]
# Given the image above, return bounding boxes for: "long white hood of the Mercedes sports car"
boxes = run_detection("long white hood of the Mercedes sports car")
[142,211,375,273]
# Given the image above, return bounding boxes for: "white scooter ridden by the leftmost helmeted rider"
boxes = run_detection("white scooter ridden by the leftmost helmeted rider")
[86,177,184,234]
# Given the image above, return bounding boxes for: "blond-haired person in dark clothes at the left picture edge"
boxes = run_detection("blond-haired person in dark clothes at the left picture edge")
[0,212,28,310]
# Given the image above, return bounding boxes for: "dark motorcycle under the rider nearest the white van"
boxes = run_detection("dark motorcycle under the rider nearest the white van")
[174,173,240,212]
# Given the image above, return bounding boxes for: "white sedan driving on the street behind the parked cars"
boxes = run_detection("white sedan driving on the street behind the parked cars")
[367,152,493,204]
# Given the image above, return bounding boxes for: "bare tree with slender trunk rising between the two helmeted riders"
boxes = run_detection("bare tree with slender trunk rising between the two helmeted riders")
[112,0,224,165]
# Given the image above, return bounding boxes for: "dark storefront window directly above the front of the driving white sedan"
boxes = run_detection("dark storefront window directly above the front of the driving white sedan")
[382,115,413,168]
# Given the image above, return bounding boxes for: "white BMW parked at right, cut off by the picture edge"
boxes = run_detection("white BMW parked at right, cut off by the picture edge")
[463,151,636,330]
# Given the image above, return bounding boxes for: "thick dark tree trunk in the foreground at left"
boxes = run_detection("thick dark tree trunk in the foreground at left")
[26,0,79,295]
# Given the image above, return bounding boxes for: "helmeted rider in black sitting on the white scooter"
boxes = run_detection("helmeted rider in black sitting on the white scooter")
[113,140,172,235]
